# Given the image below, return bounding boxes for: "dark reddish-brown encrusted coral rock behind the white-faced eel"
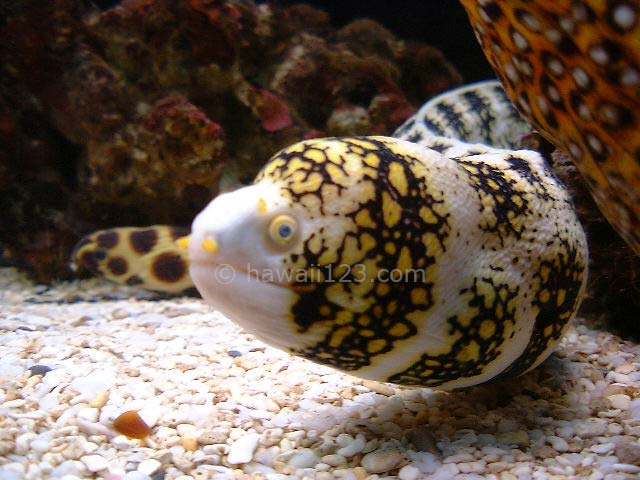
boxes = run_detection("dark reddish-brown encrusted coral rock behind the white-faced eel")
[0,0,461,281]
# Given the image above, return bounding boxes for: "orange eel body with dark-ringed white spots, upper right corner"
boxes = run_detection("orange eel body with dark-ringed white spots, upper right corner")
[461,0,640,254]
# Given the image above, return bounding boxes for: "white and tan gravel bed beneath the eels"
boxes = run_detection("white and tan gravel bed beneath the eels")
[0,269,640,480]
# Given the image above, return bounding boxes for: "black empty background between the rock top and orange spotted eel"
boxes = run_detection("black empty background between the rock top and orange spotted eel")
[94,0,495,82]
